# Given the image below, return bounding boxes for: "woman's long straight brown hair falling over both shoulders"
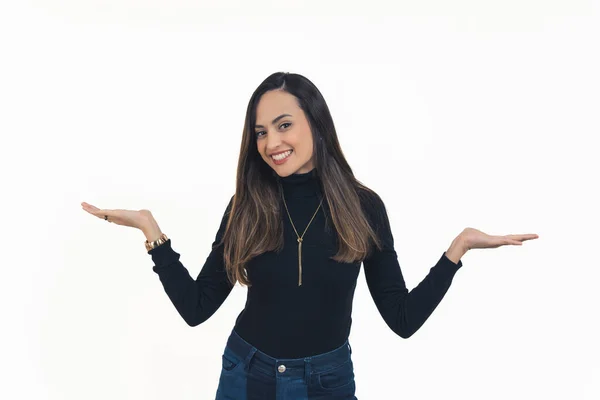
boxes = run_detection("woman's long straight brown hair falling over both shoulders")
[215,72,381,286]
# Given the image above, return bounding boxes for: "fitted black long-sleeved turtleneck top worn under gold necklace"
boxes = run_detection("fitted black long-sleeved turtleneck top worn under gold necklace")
[148,169,462,358]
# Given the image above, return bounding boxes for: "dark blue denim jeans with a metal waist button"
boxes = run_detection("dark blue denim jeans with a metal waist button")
[215,330,357,400]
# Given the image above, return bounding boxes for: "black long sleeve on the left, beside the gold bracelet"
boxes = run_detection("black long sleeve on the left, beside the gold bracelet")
[148,197,233,326]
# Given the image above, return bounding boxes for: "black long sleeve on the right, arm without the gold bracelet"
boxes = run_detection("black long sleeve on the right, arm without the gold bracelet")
[363,191,462,339]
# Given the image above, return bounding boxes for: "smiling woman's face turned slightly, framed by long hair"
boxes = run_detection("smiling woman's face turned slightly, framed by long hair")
[254,90,314,177]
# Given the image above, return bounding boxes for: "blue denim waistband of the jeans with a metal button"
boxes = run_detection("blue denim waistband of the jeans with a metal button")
[227,330,352,377]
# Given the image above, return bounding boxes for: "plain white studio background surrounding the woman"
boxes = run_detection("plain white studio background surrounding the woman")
[0,0,600,400]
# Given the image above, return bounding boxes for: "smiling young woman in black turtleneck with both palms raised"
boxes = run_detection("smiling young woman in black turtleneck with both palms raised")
[82,72,538,400]
